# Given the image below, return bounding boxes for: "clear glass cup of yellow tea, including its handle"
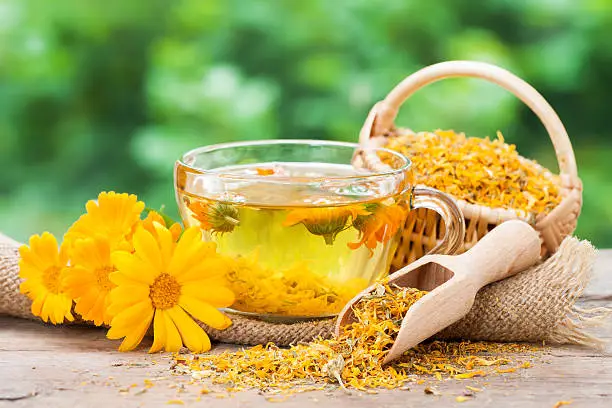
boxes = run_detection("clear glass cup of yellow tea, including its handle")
[175,140,465,321]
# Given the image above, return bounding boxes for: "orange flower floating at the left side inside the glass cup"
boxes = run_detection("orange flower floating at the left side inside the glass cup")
[188,200,240,234]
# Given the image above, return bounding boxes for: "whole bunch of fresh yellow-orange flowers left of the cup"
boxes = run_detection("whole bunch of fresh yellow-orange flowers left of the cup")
[19,192,234,352]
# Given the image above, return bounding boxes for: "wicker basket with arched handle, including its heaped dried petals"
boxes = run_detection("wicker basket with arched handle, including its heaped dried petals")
[359,61,582,269]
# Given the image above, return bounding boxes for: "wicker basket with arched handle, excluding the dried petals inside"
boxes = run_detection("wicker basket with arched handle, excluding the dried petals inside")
[359,61,582,270]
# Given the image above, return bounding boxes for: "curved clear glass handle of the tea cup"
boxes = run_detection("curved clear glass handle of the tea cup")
[410,186,465,255]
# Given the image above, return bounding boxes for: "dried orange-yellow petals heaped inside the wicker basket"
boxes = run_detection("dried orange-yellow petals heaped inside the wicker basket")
[387,130,561,213]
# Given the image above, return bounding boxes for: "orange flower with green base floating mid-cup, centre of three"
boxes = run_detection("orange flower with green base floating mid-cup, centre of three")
[283,205,370,245]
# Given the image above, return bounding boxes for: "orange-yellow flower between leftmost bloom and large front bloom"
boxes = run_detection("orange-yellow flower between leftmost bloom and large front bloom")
[62,235,115,326]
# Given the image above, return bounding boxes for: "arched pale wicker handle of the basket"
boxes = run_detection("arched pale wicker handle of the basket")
[359,61,578,183]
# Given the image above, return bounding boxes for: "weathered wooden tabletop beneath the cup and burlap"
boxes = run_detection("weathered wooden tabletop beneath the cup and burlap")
[0,250,612,408]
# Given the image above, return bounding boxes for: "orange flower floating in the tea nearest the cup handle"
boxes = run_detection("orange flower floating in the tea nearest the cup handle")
[348,204,408,250]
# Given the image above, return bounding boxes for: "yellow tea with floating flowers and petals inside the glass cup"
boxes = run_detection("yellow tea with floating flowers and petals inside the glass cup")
[178,163,408,316]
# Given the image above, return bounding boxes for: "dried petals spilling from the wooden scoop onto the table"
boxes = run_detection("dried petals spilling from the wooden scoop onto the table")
[175,285,533,393]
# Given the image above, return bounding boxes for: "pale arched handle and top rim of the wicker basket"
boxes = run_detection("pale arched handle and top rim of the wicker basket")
[359,61,582,239]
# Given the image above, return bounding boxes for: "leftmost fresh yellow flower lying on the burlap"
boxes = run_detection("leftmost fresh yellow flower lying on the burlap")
[19,232,74,324]
